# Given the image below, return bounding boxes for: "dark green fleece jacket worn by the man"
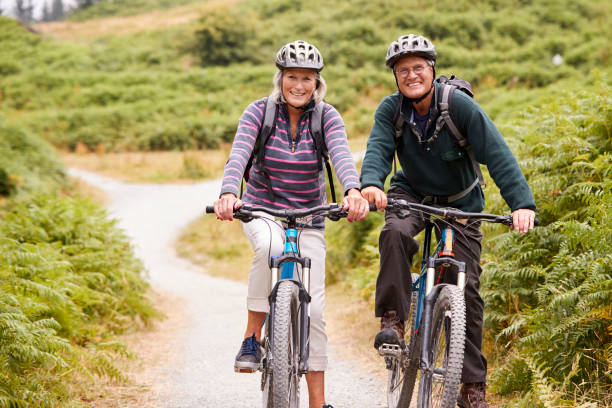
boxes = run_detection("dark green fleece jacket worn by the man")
[361,83,536,212]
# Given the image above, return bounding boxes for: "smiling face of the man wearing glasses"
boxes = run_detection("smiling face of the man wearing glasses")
[393,56,433,99]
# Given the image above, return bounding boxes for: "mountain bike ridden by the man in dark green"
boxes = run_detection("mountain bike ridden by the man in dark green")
[378,199,537,408]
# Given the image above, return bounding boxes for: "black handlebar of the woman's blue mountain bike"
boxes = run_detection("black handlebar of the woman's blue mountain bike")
[206,203,376,222]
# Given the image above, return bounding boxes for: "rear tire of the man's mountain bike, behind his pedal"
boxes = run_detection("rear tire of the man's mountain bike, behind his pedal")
[387,273,420,408]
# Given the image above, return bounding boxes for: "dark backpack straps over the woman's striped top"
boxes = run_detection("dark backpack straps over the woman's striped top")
[240,97,336,202]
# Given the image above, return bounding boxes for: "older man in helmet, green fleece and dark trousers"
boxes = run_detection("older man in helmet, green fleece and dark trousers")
[361,34,535,408]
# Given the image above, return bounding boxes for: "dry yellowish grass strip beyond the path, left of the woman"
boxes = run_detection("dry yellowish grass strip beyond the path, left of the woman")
[61,145,230,183]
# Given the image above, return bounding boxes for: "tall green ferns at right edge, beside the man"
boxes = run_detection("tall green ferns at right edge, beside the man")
[482,82,612,406]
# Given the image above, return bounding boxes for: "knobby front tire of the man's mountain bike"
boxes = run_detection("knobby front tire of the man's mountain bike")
[418,286,465,408]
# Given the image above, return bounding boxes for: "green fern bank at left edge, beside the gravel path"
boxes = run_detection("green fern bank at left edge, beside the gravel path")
[0,116,157,408]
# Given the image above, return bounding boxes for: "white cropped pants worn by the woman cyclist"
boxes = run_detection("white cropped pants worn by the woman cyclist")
[242,219,327,371]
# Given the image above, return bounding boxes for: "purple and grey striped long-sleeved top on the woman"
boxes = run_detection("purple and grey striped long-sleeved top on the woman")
[221,99,360,217]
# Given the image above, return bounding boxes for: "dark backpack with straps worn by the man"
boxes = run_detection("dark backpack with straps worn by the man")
[393,75,485,203]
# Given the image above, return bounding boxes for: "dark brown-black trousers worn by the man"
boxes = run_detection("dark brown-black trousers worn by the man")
[375,187,487,383]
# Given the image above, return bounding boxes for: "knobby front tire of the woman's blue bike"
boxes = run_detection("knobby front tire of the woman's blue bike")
[271,281,300,408]
